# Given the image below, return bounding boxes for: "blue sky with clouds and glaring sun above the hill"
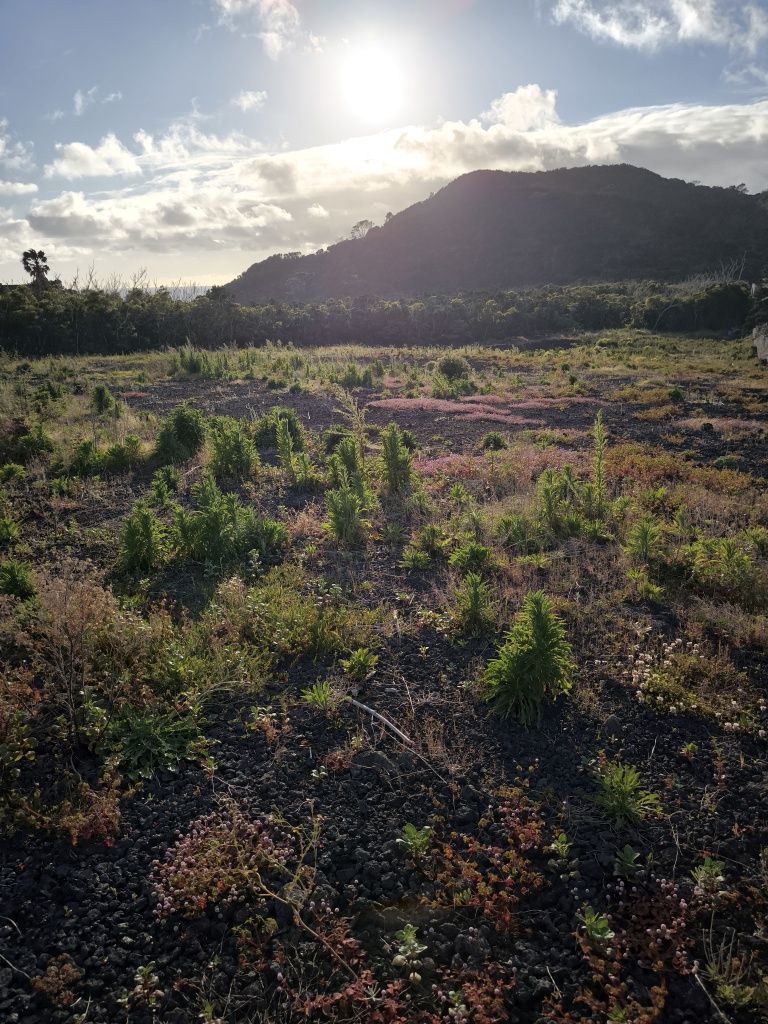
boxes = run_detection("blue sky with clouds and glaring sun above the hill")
[0,0,768,286]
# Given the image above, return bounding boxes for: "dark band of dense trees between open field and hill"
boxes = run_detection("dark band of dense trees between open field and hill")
[0,282,750,355]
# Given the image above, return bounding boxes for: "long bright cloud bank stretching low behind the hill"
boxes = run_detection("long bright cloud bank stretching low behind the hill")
[7,85,768,280]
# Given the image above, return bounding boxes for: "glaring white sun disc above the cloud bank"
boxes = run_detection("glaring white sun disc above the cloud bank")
[340,43,404,121]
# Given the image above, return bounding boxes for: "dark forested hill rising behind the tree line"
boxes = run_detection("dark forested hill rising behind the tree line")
[227,165,768,303]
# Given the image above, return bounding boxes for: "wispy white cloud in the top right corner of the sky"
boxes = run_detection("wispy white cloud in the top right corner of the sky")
[553,0,768,55]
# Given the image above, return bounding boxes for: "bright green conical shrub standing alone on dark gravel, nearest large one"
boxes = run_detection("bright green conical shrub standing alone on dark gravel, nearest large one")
[482,591,574,725]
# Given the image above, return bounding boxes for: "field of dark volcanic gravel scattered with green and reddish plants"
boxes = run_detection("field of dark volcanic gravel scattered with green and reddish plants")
[0,329,768,1024]
